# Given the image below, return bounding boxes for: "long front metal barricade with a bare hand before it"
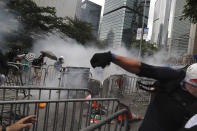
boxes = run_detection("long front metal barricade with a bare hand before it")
[0,98,119,131]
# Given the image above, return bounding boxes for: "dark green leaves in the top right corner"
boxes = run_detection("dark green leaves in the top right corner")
[181,0,197,23]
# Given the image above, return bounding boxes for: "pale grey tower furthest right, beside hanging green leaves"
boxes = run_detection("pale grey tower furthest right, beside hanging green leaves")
[168,0,191,57]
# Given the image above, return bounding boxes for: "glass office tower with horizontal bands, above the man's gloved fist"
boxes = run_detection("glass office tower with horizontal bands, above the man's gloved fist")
[99,0,150,48]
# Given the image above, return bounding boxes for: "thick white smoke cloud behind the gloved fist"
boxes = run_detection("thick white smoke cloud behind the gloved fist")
[33,33,168,81]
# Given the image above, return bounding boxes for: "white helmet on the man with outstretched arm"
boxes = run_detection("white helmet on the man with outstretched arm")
[185,63,197,87]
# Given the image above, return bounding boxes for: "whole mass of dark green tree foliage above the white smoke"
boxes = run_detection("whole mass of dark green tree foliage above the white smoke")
[7,0,95,48]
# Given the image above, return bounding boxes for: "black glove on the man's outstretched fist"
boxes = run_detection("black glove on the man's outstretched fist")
[90,51,112,68]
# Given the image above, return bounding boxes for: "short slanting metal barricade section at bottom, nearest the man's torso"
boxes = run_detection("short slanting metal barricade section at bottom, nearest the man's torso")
[80,109,129,131]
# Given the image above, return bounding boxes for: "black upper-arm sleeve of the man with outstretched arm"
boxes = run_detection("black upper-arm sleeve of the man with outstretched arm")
[136,63,185,81]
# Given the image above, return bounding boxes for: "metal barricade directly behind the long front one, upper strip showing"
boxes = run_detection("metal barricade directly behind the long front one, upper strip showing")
[0,86,92,101]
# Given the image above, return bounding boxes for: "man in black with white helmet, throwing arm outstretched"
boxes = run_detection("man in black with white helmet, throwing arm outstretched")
[90,52,197,131]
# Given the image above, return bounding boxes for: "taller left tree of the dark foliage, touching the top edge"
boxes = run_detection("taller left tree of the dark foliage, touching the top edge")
[8,0,63,33]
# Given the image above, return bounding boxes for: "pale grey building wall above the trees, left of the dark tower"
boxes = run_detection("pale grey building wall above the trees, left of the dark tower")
[33,0,82,18]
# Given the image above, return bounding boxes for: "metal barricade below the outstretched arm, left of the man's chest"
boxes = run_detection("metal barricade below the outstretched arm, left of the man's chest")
[102,74,155,98]
